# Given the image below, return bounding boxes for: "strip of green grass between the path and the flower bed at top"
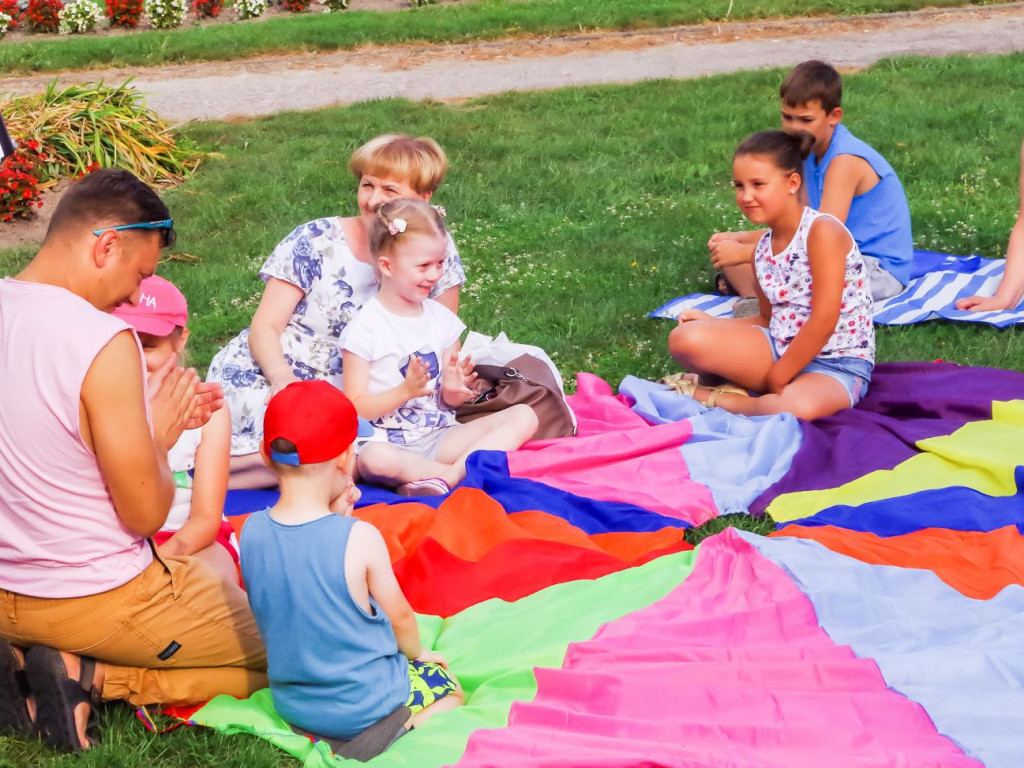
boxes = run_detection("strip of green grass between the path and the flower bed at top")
[0,0,992,74]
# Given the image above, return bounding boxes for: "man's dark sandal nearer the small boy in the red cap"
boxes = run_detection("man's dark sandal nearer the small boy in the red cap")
[25,645,99,752]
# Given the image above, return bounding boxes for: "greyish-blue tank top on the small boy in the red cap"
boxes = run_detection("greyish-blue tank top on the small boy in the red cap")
[241,510,409,739]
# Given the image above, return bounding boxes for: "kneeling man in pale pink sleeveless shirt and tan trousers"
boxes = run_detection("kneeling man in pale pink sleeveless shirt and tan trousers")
[0,170,266,751]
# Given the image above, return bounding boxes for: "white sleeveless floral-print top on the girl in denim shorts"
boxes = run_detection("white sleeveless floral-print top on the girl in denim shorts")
[754,208,874,362]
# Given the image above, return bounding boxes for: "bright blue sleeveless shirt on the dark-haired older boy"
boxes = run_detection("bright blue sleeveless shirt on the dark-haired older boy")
[804,123,913,286]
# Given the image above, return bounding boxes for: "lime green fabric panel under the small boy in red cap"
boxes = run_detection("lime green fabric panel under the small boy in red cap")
[191,550,697,768]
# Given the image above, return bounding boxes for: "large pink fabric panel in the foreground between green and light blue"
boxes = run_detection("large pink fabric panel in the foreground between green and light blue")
[459,531,981,768]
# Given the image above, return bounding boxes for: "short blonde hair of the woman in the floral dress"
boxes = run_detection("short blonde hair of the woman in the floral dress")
[348,133,447,195]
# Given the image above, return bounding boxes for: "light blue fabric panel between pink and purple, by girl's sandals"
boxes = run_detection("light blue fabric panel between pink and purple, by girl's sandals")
[618,376,803,513]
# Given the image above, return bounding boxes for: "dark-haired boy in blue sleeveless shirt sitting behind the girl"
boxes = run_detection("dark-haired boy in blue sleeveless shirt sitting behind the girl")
[708,60,913,301]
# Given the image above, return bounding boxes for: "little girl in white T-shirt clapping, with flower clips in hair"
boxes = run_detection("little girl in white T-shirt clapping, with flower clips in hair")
[341,199,538,496]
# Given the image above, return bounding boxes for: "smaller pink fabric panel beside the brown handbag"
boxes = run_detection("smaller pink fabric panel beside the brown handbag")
[508,374,718,525]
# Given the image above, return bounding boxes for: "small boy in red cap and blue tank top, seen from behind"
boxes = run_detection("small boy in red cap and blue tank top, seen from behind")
[241,381,462,739]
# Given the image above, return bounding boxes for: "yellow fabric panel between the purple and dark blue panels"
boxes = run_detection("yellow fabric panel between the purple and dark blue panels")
[768,400,1024,522]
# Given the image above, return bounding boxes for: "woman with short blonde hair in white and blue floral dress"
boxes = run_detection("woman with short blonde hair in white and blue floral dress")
[209,134,466,487]
